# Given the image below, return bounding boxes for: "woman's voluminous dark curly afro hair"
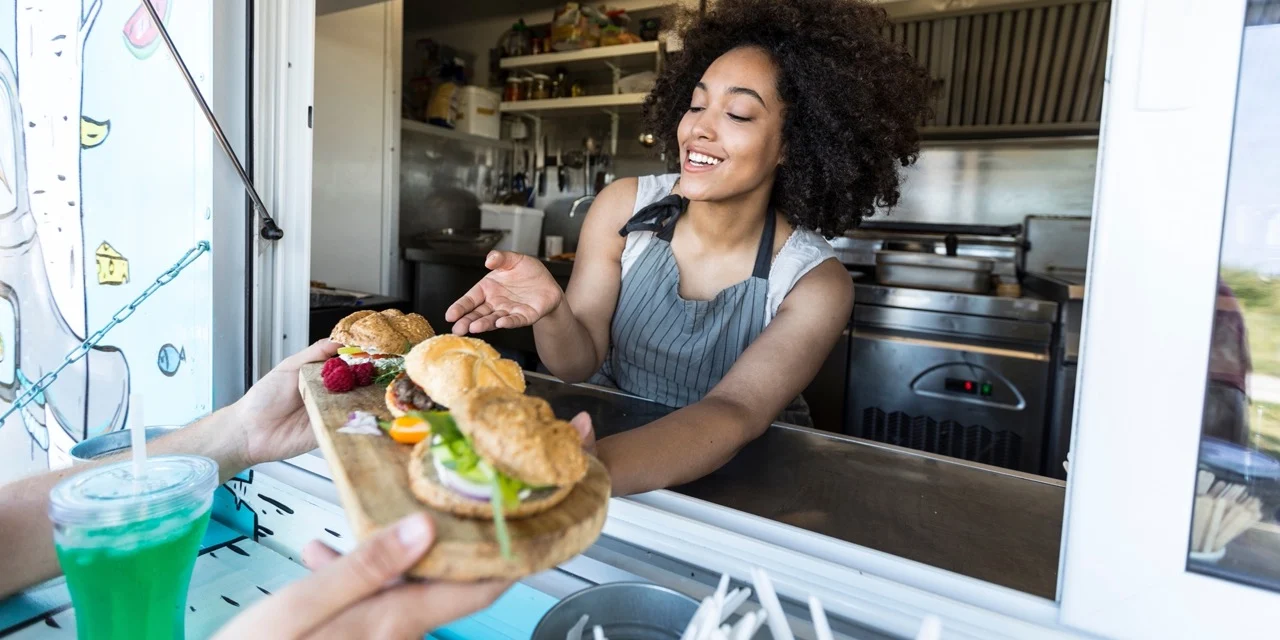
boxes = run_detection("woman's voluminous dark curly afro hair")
[644,0,931,237]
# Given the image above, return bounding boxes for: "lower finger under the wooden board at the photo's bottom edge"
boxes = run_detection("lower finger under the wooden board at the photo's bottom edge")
[308,581,511,639]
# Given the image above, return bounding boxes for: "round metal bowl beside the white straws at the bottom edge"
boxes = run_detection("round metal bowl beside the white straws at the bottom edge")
[531,582,698,640]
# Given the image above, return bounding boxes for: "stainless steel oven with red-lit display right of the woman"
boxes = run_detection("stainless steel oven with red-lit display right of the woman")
[845,284,1057,474]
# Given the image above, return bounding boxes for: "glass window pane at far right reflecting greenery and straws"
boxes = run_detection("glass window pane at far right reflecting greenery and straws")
[1187,3,1280,590]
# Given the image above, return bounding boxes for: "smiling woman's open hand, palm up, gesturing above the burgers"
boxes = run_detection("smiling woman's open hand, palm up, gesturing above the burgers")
[444,251,564,335]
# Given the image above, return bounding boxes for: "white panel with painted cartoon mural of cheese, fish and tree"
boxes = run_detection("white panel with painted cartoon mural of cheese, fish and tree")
[0,0,214,483]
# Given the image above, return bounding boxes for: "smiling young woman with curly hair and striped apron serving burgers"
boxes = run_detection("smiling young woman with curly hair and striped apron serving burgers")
[447,0,928,495]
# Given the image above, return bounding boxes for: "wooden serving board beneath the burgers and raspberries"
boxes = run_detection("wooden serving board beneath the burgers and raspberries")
[298,364,611,581]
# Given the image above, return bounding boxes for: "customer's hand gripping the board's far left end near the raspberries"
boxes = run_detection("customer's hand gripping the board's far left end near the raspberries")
[228,338,338,466]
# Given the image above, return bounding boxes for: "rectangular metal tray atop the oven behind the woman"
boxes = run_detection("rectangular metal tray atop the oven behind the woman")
[876,251,996,293]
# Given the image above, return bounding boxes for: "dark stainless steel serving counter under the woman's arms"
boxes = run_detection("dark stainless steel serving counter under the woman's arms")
[529,375,1065,598]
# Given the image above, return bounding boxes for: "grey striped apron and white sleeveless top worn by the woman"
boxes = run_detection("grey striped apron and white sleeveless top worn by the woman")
[591,174,835,426]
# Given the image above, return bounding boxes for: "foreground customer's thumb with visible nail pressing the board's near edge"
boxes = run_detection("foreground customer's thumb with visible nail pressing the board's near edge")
[227,513,434,637]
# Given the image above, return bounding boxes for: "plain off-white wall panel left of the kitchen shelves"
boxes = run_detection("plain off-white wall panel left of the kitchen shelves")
[311,1,402,293]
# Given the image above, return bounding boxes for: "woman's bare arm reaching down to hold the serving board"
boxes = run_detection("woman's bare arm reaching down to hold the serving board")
[596,260,854,495]
